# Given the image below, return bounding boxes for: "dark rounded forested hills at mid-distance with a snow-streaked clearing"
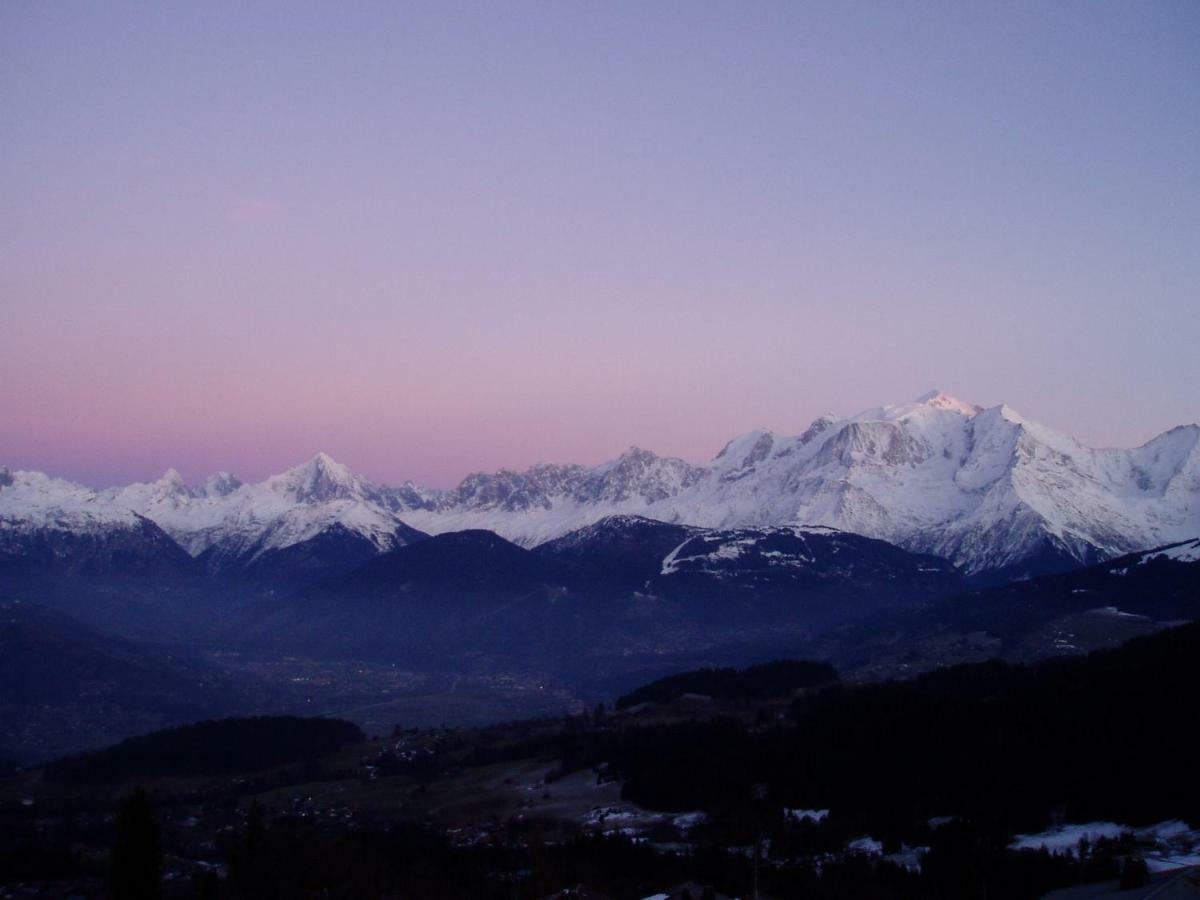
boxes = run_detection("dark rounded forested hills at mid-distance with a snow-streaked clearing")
[259,516,965,677]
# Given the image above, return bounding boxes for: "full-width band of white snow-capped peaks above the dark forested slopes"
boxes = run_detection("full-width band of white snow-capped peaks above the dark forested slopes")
[0,391,1200,574]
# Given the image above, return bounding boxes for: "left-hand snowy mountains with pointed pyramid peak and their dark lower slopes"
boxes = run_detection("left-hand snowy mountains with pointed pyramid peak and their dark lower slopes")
[0,454,426,588]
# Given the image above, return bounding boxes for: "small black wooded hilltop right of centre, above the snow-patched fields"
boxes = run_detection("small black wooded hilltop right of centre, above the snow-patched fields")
[617,660,838,709]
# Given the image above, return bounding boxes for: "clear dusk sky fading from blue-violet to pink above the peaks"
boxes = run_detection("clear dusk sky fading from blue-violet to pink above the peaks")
[0,0,1200,485]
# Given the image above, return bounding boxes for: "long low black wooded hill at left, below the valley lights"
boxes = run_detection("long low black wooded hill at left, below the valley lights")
[46,715,366,784]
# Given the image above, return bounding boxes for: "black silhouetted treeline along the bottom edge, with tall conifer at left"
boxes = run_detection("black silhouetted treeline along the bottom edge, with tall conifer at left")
[0,798,1124,900]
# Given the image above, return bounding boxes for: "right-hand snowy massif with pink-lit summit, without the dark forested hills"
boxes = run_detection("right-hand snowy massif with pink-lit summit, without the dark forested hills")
[400,391,1200,574]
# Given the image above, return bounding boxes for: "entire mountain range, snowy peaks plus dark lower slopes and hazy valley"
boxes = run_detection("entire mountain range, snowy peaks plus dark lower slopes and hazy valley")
[0,392,1200,758]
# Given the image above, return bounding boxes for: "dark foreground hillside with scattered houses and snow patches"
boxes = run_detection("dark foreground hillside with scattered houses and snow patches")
[0,625,1200,900]
